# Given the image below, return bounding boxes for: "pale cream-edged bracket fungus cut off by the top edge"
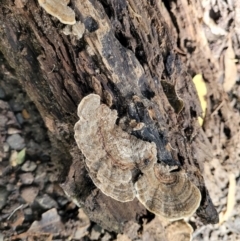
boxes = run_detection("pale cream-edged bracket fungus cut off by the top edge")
[38,0,76,25]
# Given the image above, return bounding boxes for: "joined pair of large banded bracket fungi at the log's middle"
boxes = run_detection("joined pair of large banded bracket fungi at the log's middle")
[74,94,201,221]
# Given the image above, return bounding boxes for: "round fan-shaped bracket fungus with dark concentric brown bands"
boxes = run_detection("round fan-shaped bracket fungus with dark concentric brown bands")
[135,164,201,221]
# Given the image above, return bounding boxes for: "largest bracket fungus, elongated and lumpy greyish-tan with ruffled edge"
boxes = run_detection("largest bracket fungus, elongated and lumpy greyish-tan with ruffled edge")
[74,94,157,202]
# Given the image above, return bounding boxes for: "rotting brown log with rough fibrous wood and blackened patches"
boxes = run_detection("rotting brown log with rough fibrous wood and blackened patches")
[0,0,218,232]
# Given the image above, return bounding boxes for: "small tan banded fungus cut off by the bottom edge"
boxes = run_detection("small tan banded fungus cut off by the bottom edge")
[165,220,193,241]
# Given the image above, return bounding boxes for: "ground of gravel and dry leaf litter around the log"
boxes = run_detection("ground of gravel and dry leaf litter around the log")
[0,0,240,241]
